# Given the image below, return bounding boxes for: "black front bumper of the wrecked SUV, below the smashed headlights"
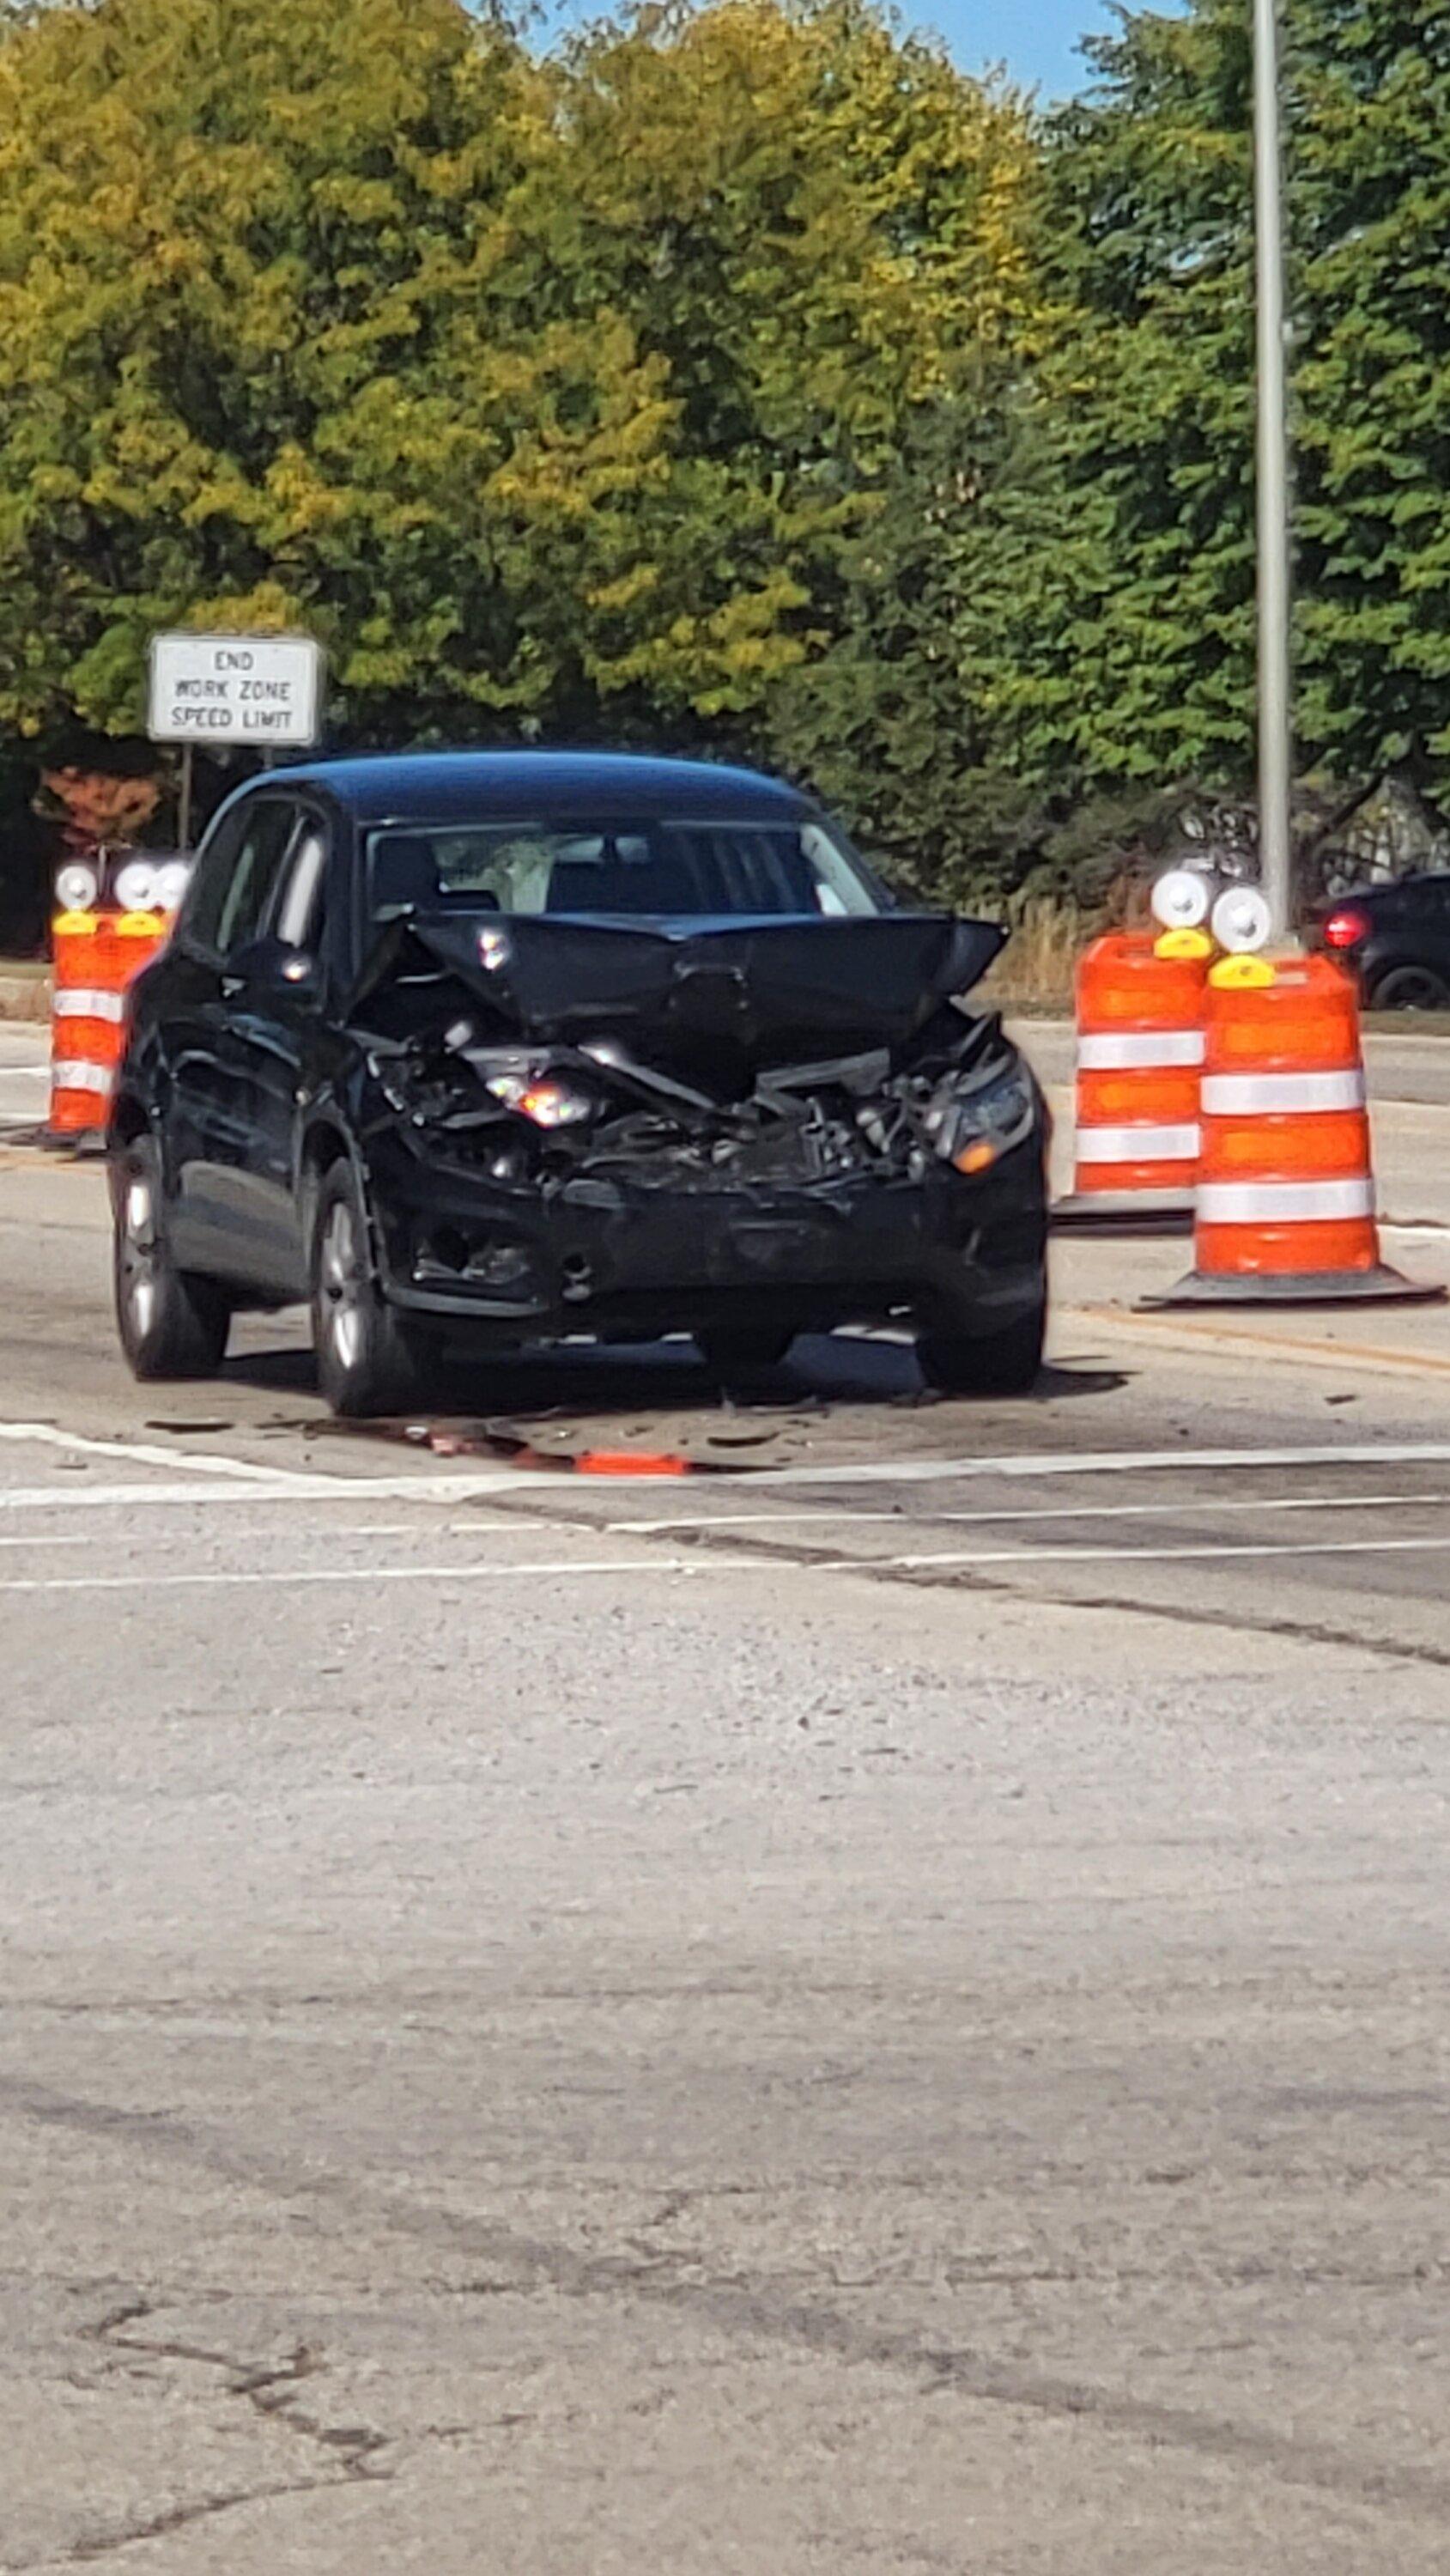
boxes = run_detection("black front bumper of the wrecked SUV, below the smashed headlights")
[368,1133,1046,1340]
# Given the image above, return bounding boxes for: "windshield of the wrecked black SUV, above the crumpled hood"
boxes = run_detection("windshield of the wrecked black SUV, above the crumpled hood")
[368,819,883,920]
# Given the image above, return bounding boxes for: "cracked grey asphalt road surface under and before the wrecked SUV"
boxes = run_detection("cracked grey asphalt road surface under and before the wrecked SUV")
[0,1131,1450,2576]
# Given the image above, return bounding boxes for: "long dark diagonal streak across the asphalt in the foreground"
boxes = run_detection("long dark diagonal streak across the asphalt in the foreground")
[0,2079,1450,2527]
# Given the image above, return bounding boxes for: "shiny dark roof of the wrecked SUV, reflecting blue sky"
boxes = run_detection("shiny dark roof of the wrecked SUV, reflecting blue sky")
[258,750,814,824]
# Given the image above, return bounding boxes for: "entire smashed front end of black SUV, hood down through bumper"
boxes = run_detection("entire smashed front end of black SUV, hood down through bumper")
[343,914,1043,1337]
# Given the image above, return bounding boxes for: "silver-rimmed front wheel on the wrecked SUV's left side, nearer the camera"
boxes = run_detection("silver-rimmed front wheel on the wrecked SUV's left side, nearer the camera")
[312,1162,428,1422]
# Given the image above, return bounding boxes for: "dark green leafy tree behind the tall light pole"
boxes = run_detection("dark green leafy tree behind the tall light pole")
[950,0,1450,814]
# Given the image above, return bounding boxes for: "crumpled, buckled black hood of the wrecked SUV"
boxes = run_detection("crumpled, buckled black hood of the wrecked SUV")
[397,912,1007,1064]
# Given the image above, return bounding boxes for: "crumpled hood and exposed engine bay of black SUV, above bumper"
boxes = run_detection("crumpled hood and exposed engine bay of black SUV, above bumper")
[350,914,1043,1193]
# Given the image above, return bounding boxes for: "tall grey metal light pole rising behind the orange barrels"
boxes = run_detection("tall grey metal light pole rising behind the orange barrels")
[1254,0,1293,940]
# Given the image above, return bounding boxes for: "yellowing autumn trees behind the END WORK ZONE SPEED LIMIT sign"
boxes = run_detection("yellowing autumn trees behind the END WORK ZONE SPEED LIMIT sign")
[0,0,1033,773]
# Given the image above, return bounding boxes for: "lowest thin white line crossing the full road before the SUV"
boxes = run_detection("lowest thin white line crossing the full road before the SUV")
[0,1538,1450,1592]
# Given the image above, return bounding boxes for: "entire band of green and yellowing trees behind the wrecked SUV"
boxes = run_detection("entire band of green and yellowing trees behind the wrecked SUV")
[0,0,1450,922]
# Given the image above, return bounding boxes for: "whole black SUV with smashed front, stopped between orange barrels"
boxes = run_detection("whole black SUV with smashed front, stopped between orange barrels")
[111,752,1046,1414]
